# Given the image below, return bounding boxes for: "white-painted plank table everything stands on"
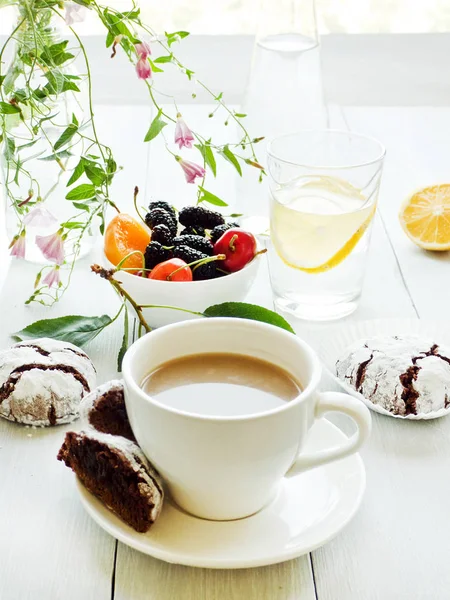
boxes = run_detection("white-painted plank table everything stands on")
[0,34,450,600]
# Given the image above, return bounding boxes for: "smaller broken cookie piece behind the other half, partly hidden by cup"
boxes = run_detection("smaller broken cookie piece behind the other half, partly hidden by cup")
[80,379,136,442]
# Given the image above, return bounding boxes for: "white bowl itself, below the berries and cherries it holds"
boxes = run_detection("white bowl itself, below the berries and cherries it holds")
[109,253,261,327]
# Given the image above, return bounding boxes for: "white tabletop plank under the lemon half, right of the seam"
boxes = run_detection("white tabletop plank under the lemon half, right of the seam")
[345,107,450,319]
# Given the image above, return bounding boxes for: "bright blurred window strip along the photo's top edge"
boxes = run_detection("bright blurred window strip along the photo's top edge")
[0,0,450,34]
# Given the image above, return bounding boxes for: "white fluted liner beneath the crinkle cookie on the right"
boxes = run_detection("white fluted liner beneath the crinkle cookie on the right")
[305,319,450,421]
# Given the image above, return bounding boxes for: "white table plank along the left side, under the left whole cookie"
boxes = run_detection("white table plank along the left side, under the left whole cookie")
[0,108,148,600]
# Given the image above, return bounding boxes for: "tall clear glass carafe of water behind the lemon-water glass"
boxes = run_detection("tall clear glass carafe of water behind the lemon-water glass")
[237,0,326,232]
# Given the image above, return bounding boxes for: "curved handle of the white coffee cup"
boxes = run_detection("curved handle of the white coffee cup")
[286,392,372,477]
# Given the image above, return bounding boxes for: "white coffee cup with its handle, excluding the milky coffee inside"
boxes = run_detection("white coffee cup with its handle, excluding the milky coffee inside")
[123,318,371,520]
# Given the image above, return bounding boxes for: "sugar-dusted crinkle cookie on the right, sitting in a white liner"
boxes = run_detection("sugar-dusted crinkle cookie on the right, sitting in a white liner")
[336,336,450,416]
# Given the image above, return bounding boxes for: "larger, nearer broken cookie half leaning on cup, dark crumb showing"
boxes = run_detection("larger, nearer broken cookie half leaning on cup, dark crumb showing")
[58,431,164,533]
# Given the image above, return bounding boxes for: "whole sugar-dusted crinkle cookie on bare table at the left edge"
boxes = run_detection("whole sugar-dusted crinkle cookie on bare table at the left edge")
[0,338,96,427]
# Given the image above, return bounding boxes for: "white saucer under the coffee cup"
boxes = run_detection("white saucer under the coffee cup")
[77,419,365,569]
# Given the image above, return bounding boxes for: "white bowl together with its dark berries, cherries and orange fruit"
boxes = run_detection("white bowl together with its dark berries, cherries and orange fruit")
[105,201,264,327]
